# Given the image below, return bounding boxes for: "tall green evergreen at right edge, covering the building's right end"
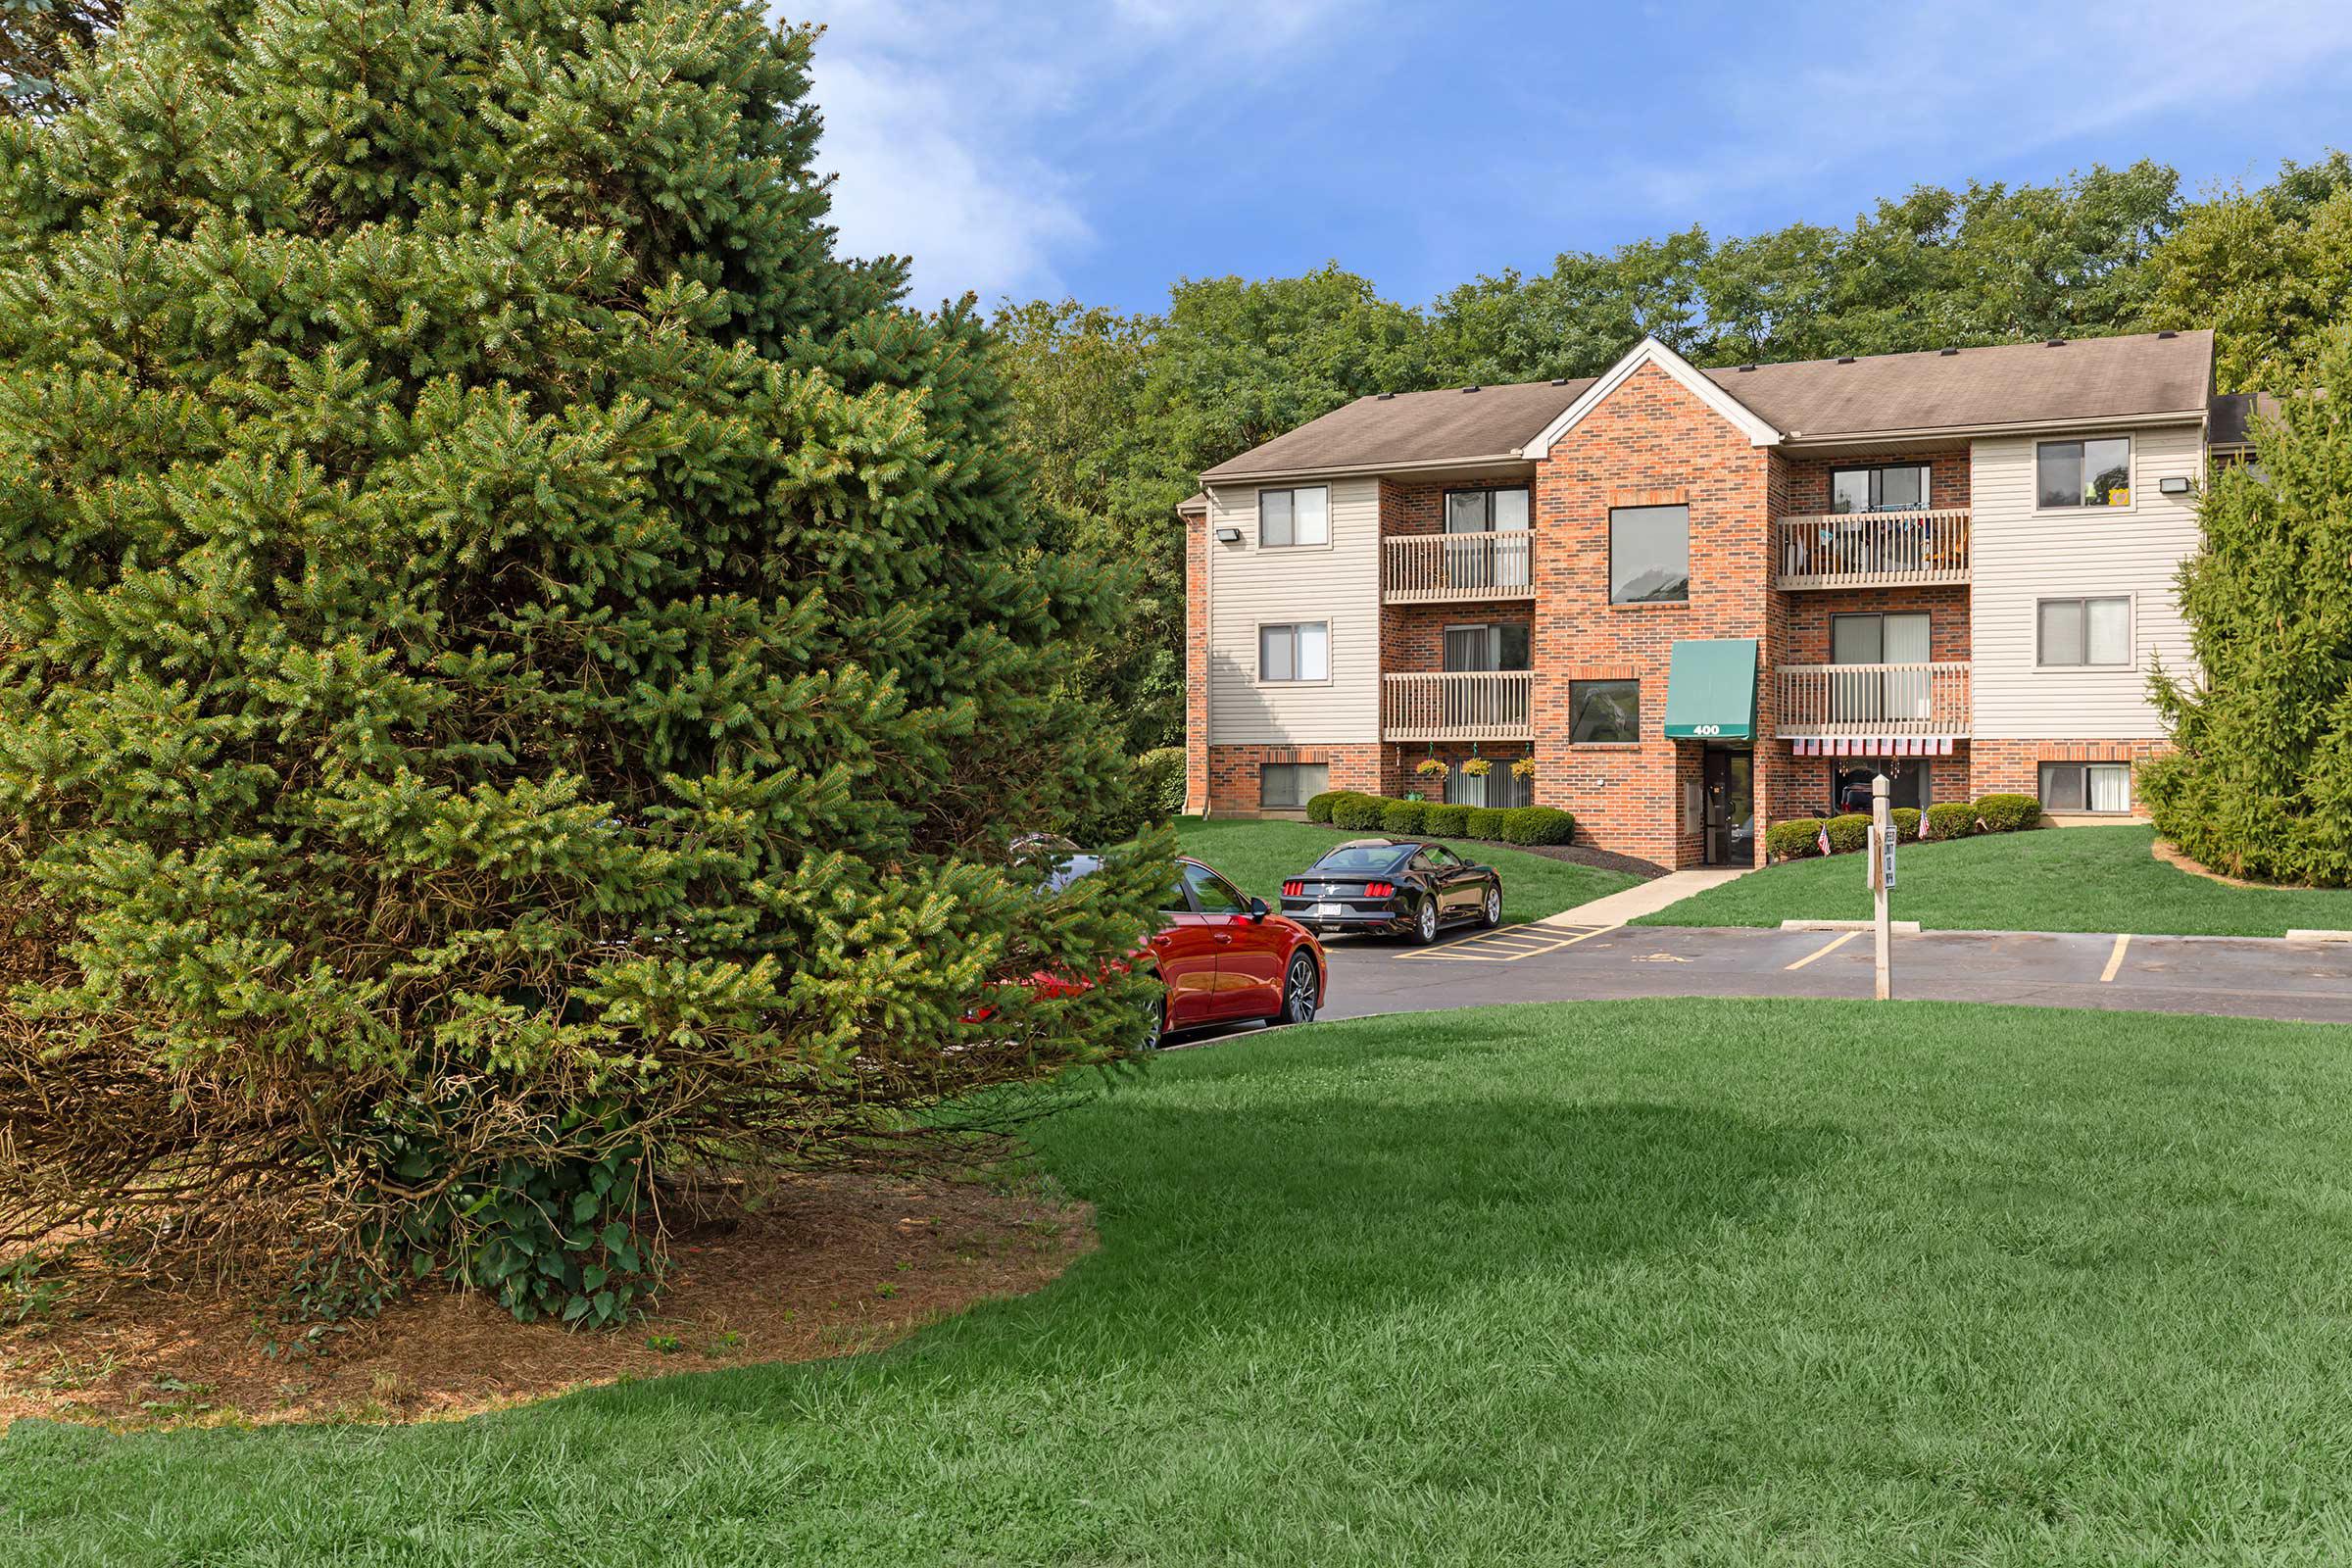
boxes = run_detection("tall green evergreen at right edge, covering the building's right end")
[2140,336,2352,886]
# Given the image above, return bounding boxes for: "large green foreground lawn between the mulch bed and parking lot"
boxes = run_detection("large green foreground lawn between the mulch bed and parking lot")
[14,1002,2352,1568]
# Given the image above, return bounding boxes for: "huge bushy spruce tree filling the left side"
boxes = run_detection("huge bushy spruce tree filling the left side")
[0,0,1166,1319]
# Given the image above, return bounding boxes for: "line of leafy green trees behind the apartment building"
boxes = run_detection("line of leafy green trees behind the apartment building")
[995,151,2352,753]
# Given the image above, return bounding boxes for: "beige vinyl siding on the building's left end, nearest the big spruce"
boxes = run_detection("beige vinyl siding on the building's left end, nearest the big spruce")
[1209,479,1381,745]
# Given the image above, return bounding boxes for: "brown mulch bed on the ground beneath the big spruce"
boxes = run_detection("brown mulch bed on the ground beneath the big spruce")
[0,1175,1094,1429]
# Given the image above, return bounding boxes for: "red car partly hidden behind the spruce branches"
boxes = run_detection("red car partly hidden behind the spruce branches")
[1030,856,1329,1051]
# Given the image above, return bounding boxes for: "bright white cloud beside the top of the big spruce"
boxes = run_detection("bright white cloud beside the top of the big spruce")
[795,0,1366,303]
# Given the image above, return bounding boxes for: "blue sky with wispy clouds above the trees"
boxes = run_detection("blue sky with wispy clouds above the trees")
[788,0,2352,311]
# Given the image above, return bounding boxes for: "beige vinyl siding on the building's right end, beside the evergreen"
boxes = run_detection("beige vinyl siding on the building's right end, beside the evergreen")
[1969,425,2204,741]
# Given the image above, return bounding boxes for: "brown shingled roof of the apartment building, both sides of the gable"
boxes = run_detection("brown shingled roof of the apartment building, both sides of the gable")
[1201,331,2213,484]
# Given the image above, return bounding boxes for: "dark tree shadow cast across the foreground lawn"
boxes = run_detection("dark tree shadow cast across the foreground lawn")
[588,1093,1837,1413]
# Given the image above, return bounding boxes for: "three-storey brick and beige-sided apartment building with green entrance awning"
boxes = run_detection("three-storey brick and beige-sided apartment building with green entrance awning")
[1183,331,2246,867]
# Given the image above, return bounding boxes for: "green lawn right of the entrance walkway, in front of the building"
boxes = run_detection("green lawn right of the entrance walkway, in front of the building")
[1635,827,2352,936]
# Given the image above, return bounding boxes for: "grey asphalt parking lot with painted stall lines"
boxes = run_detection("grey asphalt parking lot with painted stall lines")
[1322,926,2352,1022]
